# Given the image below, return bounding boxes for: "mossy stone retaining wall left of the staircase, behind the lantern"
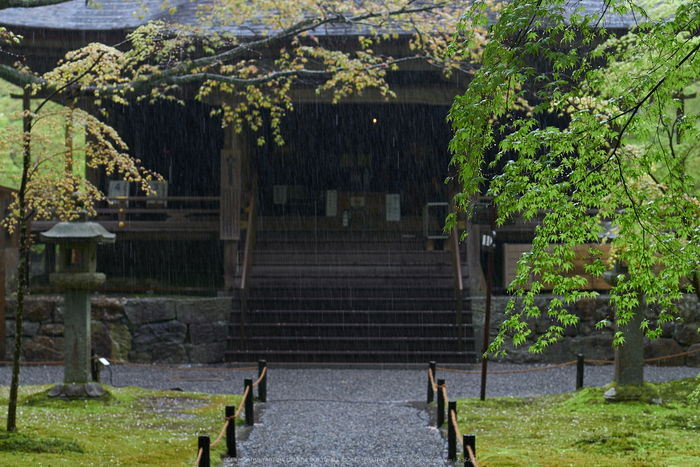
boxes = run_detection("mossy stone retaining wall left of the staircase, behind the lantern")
[4,295,231,363]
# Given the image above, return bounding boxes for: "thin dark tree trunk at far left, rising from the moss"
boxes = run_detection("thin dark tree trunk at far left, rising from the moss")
[7,88,32,433]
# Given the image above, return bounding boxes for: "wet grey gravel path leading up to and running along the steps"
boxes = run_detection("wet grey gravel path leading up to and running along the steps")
[0,363,698,467]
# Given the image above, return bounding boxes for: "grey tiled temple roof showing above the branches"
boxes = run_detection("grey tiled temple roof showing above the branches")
[0,0,634,36]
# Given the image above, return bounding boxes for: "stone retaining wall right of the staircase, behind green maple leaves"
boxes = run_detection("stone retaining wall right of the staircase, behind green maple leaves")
[471,295,700,367]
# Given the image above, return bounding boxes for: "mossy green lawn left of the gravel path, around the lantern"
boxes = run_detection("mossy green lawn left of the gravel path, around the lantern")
[0,386,242,467]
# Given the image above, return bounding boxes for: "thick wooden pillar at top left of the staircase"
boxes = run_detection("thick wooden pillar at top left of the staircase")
[219,126,247,291]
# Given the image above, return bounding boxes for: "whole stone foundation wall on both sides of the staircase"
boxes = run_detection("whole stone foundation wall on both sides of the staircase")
[4,295,700,367]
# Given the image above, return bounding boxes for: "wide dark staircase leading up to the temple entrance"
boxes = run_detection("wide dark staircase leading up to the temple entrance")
[226,234,476,363]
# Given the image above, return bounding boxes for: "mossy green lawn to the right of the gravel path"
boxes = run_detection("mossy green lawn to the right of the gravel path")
[457,379,700,467]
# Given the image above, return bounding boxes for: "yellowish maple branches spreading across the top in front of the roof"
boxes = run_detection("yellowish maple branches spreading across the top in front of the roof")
[0,0,485,144]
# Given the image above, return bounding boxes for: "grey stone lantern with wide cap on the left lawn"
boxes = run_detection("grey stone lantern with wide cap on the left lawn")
[41,212,116,398]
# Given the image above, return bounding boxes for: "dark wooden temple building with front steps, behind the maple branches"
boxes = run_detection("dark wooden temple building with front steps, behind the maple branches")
[0,0,628,363]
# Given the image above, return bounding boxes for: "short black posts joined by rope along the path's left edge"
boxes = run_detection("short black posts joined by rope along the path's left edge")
[189,360,267,467]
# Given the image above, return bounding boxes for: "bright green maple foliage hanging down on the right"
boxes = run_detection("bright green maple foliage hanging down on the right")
[449,0,700,352]
